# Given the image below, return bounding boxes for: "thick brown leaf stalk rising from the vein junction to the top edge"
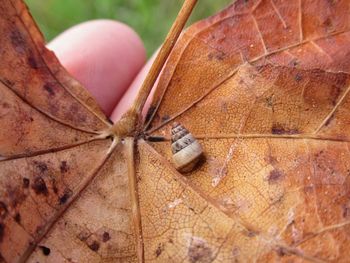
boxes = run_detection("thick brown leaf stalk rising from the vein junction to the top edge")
[111,0,198,136]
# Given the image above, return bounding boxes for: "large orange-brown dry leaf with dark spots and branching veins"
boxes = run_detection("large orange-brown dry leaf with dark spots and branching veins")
[0,0,350,262]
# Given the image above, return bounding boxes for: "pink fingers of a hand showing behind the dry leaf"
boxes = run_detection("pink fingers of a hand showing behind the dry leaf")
[48,20,152,121]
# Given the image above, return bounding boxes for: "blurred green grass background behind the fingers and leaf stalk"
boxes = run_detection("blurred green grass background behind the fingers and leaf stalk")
[25,0,232,56]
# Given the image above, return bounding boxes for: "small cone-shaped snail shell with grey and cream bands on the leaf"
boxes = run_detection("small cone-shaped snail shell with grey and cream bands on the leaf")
[171,122,203,173]
